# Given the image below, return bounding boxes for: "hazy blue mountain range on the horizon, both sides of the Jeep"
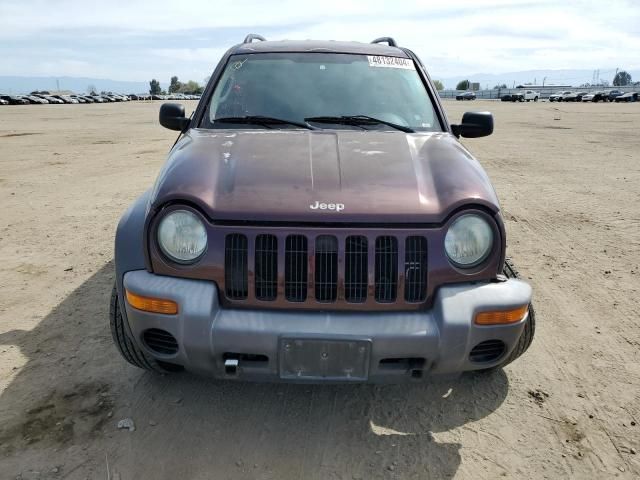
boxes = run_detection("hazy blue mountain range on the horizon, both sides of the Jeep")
[0,69,640,94]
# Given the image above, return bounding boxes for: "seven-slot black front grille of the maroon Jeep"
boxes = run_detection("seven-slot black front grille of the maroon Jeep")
[224,233,427,308]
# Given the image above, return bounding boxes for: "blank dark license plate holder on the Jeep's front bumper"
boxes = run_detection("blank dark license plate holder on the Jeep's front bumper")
[280,338,371,381]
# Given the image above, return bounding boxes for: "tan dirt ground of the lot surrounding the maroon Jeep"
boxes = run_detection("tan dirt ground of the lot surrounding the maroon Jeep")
[0,101,640,480]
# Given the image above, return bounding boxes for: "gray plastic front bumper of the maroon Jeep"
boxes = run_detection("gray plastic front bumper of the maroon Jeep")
[120,270,531,382]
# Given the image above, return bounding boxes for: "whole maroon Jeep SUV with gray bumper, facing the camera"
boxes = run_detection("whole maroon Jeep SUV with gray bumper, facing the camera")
[110,35,535,383]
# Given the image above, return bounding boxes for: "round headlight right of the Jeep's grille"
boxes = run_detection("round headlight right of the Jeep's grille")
[444,213,493,268]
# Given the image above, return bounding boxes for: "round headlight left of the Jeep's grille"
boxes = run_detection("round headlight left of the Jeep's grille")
[158,210,207,263]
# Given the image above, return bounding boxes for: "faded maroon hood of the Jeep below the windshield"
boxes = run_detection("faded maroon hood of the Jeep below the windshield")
[151,129,499,224]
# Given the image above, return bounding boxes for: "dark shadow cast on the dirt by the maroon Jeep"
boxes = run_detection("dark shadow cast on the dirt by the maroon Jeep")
[0,262,508,480]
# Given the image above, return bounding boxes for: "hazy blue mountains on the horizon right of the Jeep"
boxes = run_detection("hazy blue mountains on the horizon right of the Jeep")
[440,68,640,89]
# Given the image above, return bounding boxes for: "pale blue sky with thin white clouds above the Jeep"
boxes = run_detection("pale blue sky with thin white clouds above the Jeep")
[0,0,640,83]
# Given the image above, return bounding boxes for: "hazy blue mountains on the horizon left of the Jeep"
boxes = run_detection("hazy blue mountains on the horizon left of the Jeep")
[0,76,160,94]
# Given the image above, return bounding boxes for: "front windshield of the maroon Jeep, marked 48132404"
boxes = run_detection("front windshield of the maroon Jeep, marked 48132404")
[202,53,442,131]
